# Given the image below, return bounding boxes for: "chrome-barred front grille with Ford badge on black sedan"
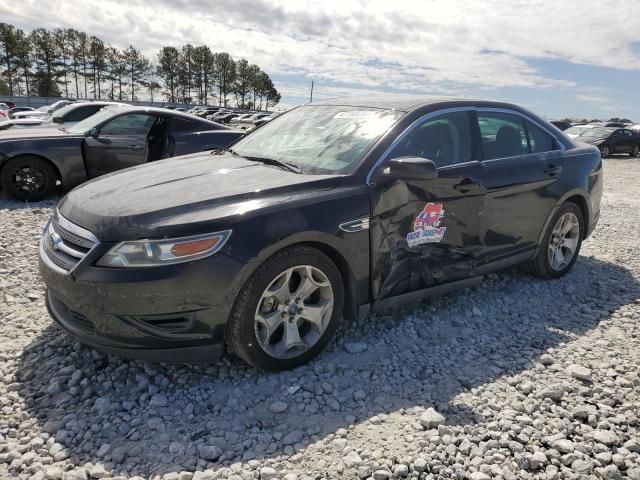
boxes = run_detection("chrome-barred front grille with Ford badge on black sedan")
[43,212,98,272]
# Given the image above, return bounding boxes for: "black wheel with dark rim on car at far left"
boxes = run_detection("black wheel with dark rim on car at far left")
[0,155,58,202]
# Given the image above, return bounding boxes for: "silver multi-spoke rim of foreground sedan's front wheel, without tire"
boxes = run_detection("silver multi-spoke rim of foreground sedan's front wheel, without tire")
[254,265,333,359]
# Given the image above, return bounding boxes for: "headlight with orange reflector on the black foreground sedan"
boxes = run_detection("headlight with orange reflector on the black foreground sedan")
[98,230,231,268]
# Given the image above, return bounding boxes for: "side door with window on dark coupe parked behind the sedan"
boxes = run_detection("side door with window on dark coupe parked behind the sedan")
[83,113,158,178]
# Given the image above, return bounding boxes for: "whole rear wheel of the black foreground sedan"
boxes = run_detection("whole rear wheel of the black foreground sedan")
[526,203,584,278]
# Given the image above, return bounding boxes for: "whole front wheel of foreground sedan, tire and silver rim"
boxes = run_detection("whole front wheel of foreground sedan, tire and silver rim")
[226,246,344,371]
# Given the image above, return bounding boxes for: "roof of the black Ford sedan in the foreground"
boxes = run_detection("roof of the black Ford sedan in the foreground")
[307,94,522,112]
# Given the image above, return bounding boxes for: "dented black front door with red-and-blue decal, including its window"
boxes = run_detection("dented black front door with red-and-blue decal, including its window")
[370,109,486,300]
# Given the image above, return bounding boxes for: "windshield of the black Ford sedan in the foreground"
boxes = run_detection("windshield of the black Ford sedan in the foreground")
[233,106,402,174]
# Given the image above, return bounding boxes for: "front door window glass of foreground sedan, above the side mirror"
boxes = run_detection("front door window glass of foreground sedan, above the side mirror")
[389,112,471,167]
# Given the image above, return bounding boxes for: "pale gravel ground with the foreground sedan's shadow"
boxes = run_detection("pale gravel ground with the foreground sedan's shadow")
[0,158,640,480]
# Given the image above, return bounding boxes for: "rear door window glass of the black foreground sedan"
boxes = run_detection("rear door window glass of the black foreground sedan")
[478,112,529,160]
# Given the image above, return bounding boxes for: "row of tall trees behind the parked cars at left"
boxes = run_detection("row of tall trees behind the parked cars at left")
[0,23,280,110]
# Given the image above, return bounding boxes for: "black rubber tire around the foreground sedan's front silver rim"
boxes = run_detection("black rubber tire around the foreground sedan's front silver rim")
[225,245,344,371]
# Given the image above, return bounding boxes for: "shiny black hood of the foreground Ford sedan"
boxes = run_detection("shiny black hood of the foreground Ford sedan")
[58,153,340,241]
